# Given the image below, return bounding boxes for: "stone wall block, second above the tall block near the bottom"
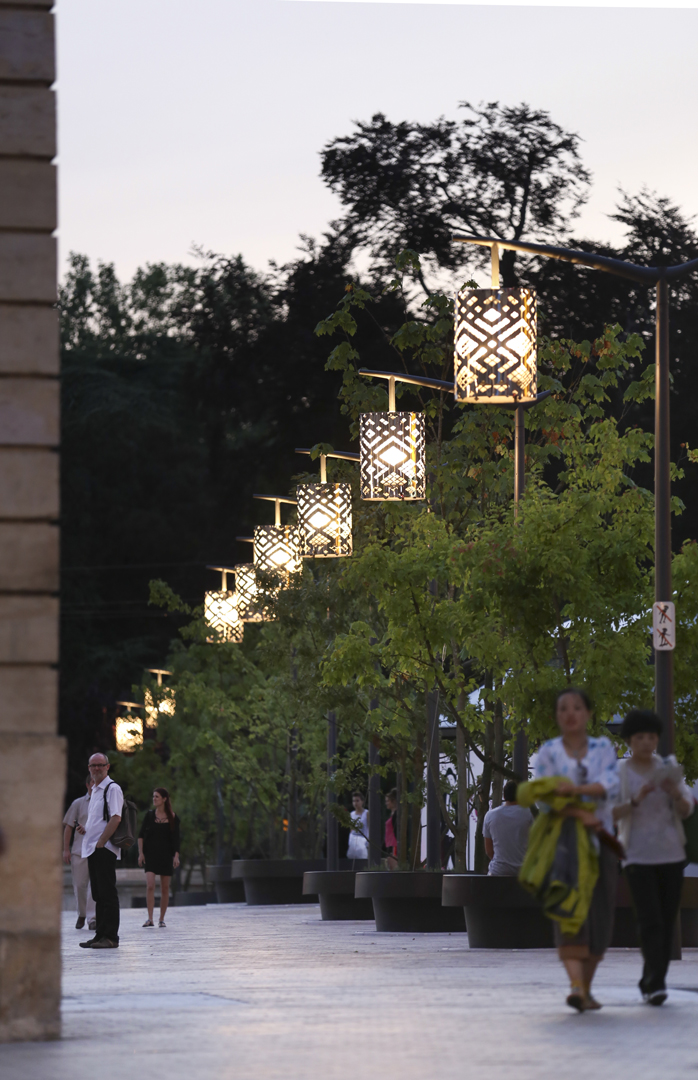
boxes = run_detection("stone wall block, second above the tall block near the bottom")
[0,595,58,664]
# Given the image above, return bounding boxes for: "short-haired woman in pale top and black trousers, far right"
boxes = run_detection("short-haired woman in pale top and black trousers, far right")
[614,708,694,1005]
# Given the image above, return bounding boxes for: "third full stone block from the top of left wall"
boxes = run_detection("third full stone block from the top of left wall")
[0,158,57,232]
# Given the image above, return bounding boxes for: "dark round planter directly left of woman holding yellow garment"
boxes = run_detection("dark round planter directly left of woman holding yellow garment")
[443,874,553,948]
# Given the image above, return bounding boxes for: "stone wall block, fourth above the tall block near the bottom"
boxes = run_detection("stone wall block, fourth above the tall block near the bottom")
[0,449,58,521]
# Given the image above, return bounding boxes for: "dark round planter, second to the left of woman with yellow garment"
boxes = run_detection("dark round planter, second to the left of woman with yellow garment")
[355,870,466,934]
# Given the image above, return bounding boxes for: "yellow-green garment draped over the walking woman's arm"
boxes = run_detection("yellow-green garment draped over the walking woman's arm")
[516,777,599,935]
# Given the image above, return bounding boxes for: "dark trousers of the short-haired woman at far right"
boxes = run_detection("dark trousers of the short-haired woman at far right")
[626,863,684,994]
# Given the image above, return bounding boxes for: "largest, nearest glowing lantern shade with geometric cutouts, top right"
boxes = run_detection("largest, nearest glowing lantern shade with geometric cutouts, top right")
[455,288,537,405]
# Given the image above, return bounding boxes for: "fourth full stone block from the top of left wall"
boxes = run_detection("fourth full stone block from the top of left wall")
[0,234,56,303]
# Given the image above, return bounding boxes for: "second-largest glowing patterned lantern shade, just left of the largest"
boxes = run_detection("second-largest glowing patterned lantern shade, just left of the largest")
[359,413,427,502]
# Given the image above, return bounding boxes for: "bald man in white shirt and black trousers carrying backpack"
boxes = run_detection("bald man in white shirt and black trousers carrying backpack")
[80,754,123,948]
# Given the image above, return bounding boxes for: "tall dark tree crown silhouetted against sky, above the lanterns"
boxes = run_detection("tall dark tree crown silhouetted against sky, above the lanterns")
[322,102,591,291]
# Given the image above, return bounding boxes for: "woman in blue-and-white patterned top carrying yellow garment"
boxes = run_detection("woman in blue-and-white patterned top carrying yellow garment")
[536,687,618,1012]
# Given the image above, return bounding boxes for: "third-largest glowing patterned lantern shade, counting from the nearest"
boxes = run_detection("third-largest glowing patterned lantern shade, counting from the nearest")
[296,484,351,558]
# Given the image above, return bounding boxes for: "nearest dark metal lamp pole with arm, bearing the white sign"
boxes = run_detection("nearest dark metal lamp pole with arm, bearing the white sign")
[452,234,698,754]
